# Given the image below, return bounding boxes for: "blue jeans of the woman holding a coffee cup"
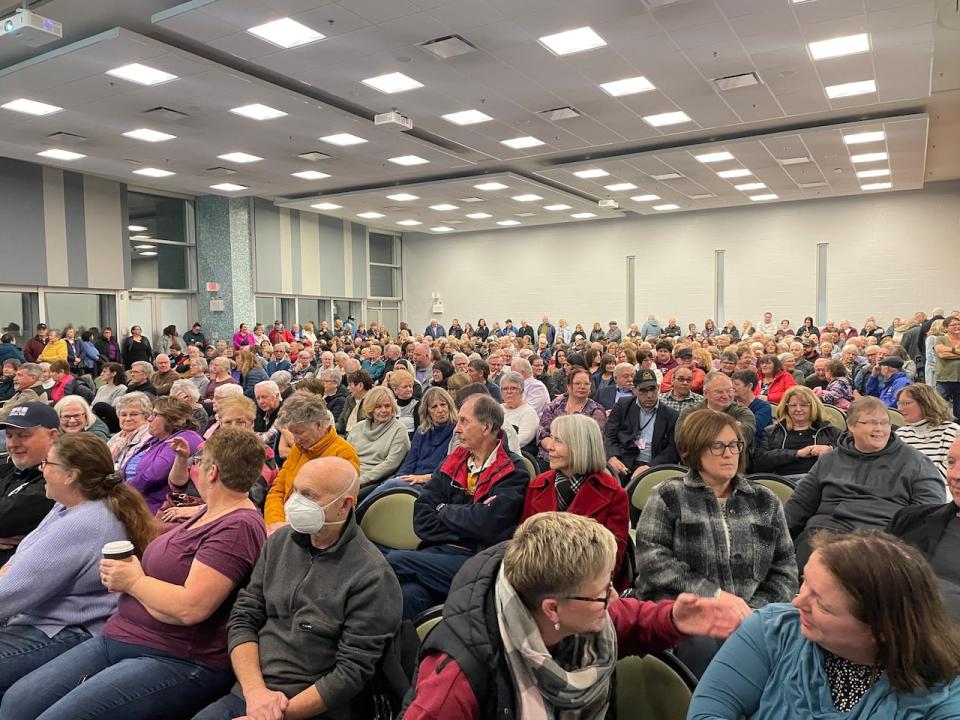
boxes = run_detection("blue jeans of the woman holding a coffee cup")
[0,637,233,720]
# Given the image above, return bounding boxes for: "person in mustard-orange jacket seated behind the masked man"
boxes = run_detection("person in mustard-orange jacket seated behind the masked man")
[263,392,360,535]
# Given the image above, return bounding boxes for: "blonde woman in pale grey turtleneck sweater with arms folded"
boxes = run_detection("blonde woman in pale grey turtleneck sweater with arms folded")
[347,386,410,497]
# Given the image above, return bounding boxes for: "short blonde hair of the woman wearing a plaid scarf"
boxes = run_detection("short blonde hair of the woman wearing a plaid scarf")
[503,512,617,610]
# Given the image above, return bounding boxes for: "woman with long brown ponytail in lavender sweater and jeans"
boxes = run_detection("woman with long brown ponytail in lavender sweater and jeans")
[0,433,154,697]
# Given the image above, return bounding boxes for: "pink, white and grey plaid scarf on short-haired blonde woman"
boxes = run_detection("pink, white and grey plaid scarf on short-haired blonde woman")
[496,567,617,720]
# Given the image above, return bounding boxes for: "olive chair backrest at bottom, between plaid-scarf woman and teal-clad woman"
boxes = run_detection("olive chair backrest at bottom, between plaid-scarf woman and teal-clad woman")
[617,653,696,720]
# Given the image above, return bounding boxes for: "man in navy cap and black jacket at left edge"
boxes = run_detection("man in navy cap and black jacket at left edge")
[0,404,60,567]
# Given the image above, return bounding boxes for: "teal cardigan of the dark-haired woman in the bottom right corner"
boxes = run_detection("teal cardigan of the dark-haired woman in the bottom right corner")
[687,604,960,720]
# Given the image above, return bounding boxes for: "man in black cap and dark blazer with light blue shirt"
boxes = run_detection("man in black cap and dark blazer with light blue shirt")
[603,366,679,483]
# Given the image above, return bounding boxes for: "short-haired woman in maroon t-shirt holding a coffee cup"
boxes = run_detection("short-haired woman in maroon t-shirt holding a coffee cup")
[0,428,266,720]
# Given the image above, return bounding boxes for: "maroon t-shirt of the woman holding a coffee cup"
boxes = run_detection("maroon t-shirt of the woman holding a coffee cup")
[103,509,267,670]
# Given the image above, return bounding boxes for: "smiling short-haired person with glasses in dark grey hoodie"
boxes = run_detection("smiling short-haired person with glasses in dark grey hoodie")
[784,397,943,571]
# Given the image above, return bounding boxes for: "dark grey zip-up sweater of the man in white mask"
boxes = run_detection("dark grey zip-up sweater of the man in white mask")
[228,516,402,720]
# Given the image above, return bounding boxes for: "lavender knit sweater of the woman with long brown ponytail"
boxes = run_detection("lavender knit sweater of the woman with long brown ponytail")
[0,500,128,637]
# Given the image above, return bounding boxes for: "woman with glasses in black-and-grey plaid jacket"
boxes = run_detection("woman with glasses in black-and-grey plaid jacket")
[636,410,798,676]
